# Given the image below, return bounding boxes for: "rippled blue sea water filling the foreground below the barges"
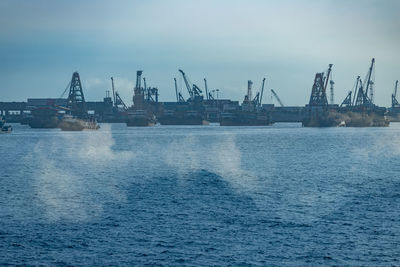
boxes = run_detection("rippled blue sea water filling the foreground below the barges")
[0,123,400,266]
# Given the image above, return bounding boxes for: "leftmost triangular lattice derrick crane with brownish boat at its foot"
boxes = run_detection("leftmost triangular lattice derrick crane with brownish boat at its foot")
[58,72,100,131]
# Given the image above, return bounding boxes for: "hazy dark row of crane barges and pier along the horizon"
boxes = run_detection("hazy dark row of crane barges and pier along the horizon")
[0,58,400,132]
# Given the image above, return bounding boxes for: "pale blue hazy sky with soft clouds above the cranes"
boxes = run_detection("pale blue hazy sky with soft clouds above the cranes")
[0,0,400,106]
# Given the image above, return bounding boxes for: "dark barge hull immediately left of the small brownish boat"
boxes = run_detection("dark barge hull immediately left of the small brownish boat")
[28,107,60,128]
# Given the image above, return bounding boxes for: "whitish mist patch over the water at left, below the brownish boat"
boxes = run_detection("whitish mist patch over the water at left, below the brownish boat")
[29,125,134,224]
